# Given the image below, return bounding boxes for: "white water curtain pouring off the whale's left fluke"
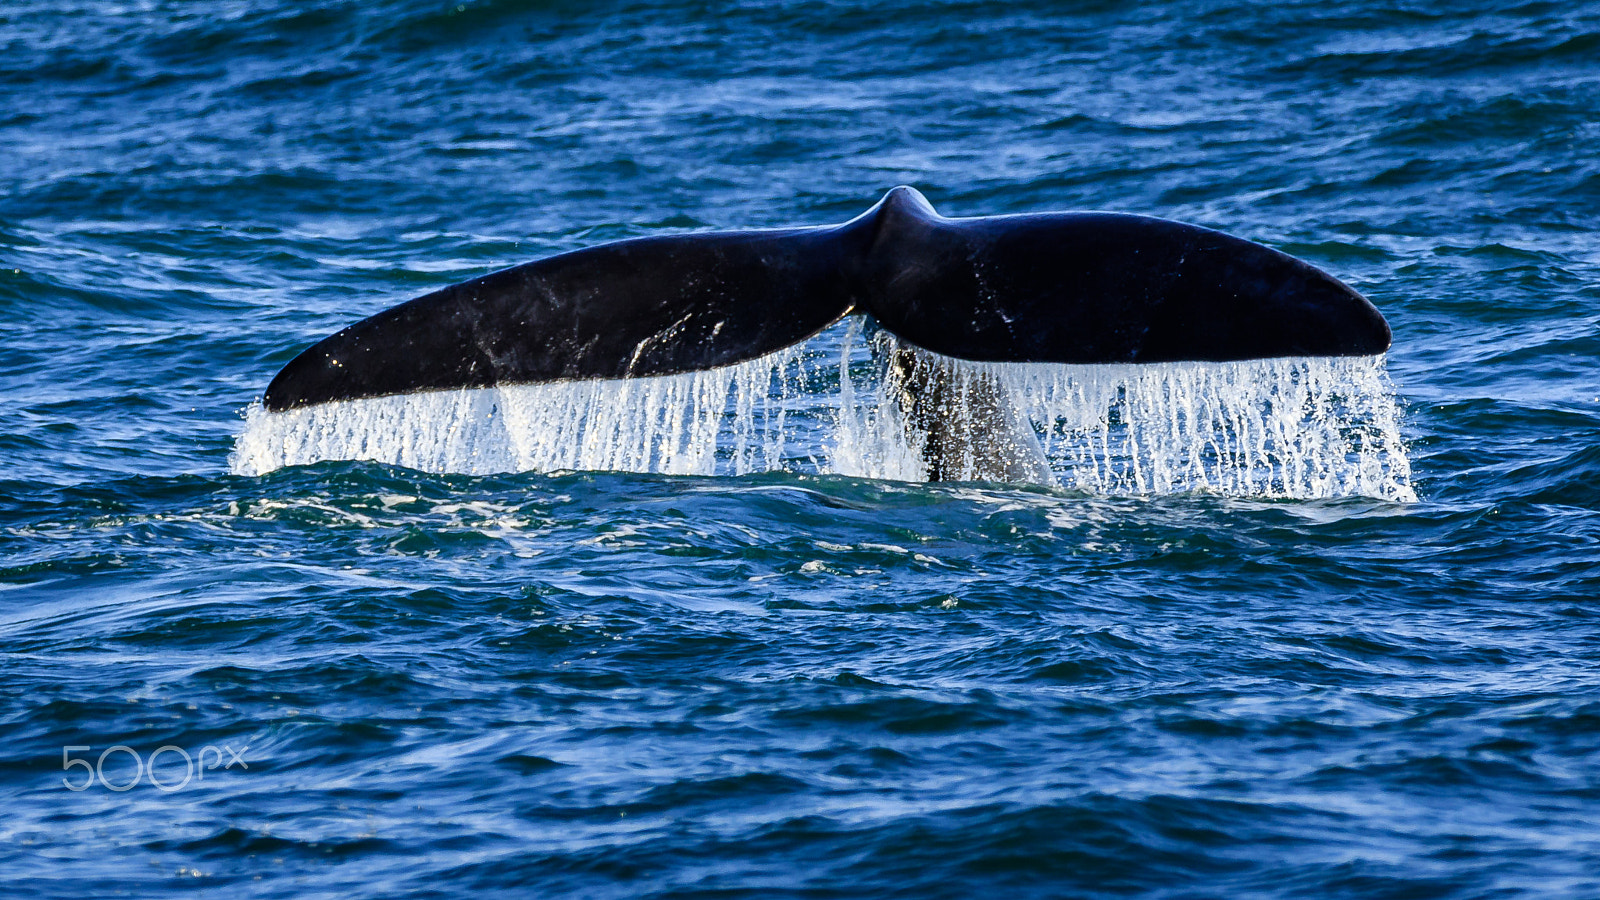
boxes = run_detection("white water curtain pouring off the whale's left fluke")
[230,348,803,476]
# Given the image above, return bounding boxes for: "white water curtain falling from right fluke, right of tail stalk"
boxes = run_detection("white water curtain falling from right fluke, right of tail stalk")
[968,349,1416,501]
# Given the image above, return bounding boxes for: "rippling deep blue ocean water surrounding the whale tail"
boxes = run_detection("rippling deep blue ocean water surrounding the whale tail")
[0,0,1600,898]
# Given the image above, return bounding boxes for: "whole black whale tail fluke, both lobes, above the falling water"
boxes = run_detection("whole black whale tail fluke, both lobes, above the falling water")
[264,187,1389,412]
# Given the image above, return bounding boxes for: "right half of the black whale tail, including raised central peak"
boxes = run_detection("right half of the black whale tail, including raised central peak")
[859,189,1389,364]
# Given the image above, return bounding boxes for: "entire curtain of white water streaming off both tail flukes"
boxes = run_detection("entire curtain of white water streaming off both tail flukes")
[230,320,1416,501]
